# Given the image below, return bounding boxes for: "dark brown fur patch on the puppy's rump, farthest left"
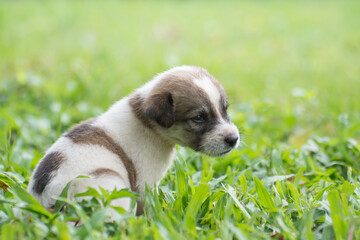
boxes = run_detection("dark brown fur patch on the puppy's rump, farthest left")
[33,152,65,194]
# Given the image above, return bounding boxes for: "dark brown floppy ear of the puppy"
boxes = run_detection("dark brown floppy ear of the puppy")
[144,92,175,128]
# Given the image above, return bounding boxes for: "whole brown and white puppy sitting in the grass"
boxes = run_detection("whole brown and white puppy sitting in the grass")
[29,66,240,212]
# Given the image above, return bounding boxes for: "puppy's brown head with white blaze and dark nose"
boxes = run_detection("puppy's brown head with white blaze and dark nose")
[142,66,240,156]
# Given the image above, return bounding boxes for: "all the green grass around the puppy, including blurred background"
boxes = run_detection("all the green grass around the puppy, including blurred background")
[0,1,360,240]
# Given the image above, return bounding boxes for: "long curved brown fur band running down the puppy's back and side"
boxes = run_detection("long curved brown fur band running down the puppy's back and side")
[65,121,137,191]
